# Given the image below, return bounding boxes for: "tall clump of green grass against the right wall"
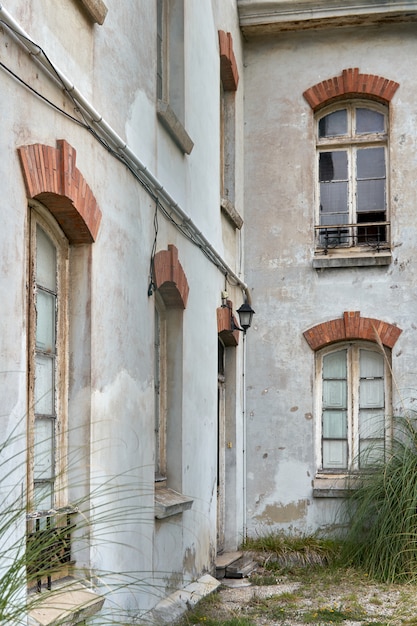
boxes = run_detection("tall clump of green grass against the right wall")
[344,415,417,582]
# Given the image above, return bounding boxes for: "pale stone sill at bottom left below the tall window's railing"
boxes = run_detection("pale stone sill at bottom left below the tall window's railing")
[29,581,104,626]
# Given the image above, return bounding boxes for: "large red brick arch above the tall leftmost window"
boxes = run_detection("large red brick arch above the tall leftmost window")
[18,140,101,244]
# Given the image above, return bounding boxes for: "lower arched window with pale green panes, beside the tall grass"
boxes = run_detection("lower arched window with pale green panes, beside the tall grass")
[316,341,391,473]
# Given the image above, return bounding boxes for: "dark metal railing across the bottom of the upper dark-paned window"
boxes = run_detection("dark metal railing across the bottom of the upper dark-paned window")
[314,222,390,254]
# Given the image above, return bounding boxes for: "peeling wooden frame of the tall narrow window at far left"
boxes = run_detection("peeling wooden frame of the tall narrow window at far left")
[27,203,69,513]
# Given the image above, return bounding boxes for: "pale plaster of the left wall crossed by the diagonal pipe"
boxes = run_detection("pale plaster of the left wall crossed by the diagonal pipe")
[0,0,243,613]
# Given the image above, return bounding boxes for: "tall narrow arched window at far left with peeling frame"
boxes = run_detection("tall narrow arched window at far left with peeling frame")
[28,206,68,513]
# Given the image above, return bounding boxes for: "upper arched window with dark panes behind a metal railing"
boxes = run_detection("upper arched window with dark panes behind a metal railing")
[316,100,390,252]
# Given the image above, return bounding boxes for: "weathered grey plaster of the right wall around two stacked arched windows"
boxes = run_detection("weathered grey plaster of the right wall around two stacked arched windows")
[245,24,417,532]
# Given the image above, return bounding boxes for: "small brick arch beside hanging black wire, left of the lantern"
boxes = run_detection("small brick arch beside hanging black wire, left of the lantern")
[153,244,189,309]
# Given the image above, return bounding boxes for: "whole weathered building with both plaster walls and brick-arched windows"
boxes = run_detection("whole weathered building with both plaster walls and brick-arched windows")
[0,0,417,624]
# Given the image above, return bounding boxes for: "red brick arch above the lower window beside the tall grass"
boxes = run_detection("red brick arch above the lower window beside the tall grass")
[303,311,402,350]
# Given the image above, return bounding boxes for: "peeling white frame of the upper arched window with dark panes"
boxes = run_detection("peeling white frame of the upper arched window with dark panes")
[315,99,390,252]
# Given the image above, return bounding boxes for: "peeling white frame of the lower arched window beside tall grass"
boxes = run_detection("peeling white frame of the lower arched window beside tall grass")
[315,341,392,475]
